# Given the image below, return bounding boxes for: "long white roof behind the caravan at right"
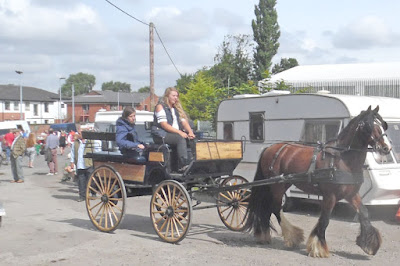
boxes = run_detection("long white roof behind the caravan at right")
[268,62,400,83]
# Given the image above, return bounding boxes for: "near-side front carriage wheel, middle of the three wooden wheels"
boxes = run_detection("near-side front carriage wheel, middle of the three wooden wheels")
[150,180,192,243]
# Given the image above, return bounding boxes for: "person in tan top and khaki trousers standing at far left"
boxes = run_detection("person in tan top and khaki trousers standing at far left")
[10,129,26,183]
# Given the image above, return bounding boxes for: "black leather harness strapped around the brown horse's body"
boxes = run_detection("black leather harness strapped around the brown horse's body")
[269,143,364,185]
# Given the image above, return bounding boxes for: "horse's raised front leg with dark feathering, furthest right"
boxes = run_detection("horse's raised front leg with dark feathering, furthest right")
[348,193,382,255]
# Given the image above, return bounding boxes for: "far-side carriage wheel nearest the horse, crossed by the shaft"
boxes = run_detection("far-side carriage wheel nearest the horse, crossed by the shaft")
[217,176,251,231]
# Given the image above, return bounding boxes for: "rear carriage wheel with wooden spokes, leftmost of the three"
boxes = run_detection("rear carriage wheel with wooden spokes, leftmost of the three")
[86,165,126,232]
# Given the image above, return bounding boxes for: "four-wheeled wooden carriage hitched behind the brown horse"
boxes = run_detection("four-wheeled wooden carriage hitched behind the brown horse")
[82,132,249,243]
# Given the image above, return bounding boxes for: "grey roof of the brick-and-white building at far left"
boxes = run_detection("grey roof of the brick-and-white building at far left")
[0,84,59,102]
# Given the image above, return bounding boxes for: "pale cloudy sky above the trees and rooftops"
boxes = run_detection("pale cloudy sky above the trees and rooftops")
[0,0,400,95]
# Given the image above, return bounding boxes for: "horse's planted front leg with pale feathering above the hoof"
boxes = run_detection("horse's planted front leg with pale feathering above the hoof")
[307,194,336,258]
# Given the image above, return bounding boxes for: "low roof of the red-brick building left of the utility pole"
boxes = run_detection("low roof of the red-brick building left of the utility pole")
[65,90,150,104]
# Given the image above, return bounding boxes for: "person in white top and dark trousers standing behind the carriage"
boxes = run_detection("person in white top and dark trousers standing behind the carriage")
[71,132,93,202]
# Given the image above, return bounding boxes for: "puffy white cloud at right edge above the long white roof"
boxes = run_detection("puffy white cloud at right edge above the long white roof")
[332,16,400,49]
